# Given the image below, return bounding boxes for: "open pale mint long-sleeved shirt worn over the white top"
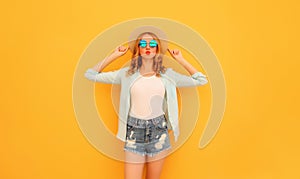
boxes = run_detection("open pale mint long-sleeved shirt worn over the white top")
[85,67,208,141]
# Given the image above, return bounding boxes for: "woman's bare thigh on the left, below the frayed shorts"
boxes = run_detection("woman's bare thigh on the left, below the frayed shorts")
[125,151,146,179]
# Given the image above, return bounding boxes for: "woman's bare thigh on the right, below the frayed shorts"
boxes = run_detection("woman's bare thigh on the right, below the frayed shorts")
[146,150,168,179]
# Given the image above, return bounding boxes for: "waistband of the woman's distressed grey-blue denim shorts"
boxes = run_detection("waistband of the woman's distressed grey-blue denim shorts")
[127,114,166,128]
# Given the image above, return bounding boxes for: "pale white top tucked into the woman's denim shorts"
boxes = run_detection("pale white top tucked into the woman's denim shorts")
[130,75,165,119]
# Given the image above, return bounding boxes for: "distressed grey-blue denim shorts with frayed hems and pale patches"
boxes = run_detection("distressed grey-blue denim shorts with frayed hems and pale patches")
[124,115,171,157]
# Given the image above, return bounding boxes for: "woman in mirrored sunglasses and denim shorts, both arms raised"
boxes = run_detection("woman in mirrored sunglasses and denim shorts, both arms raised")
[85,32,207,179]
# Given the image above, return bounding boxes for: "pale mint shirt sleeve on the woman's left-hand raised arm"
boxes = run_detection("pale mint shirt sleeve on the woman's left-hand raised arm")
[84,68,122,84]
